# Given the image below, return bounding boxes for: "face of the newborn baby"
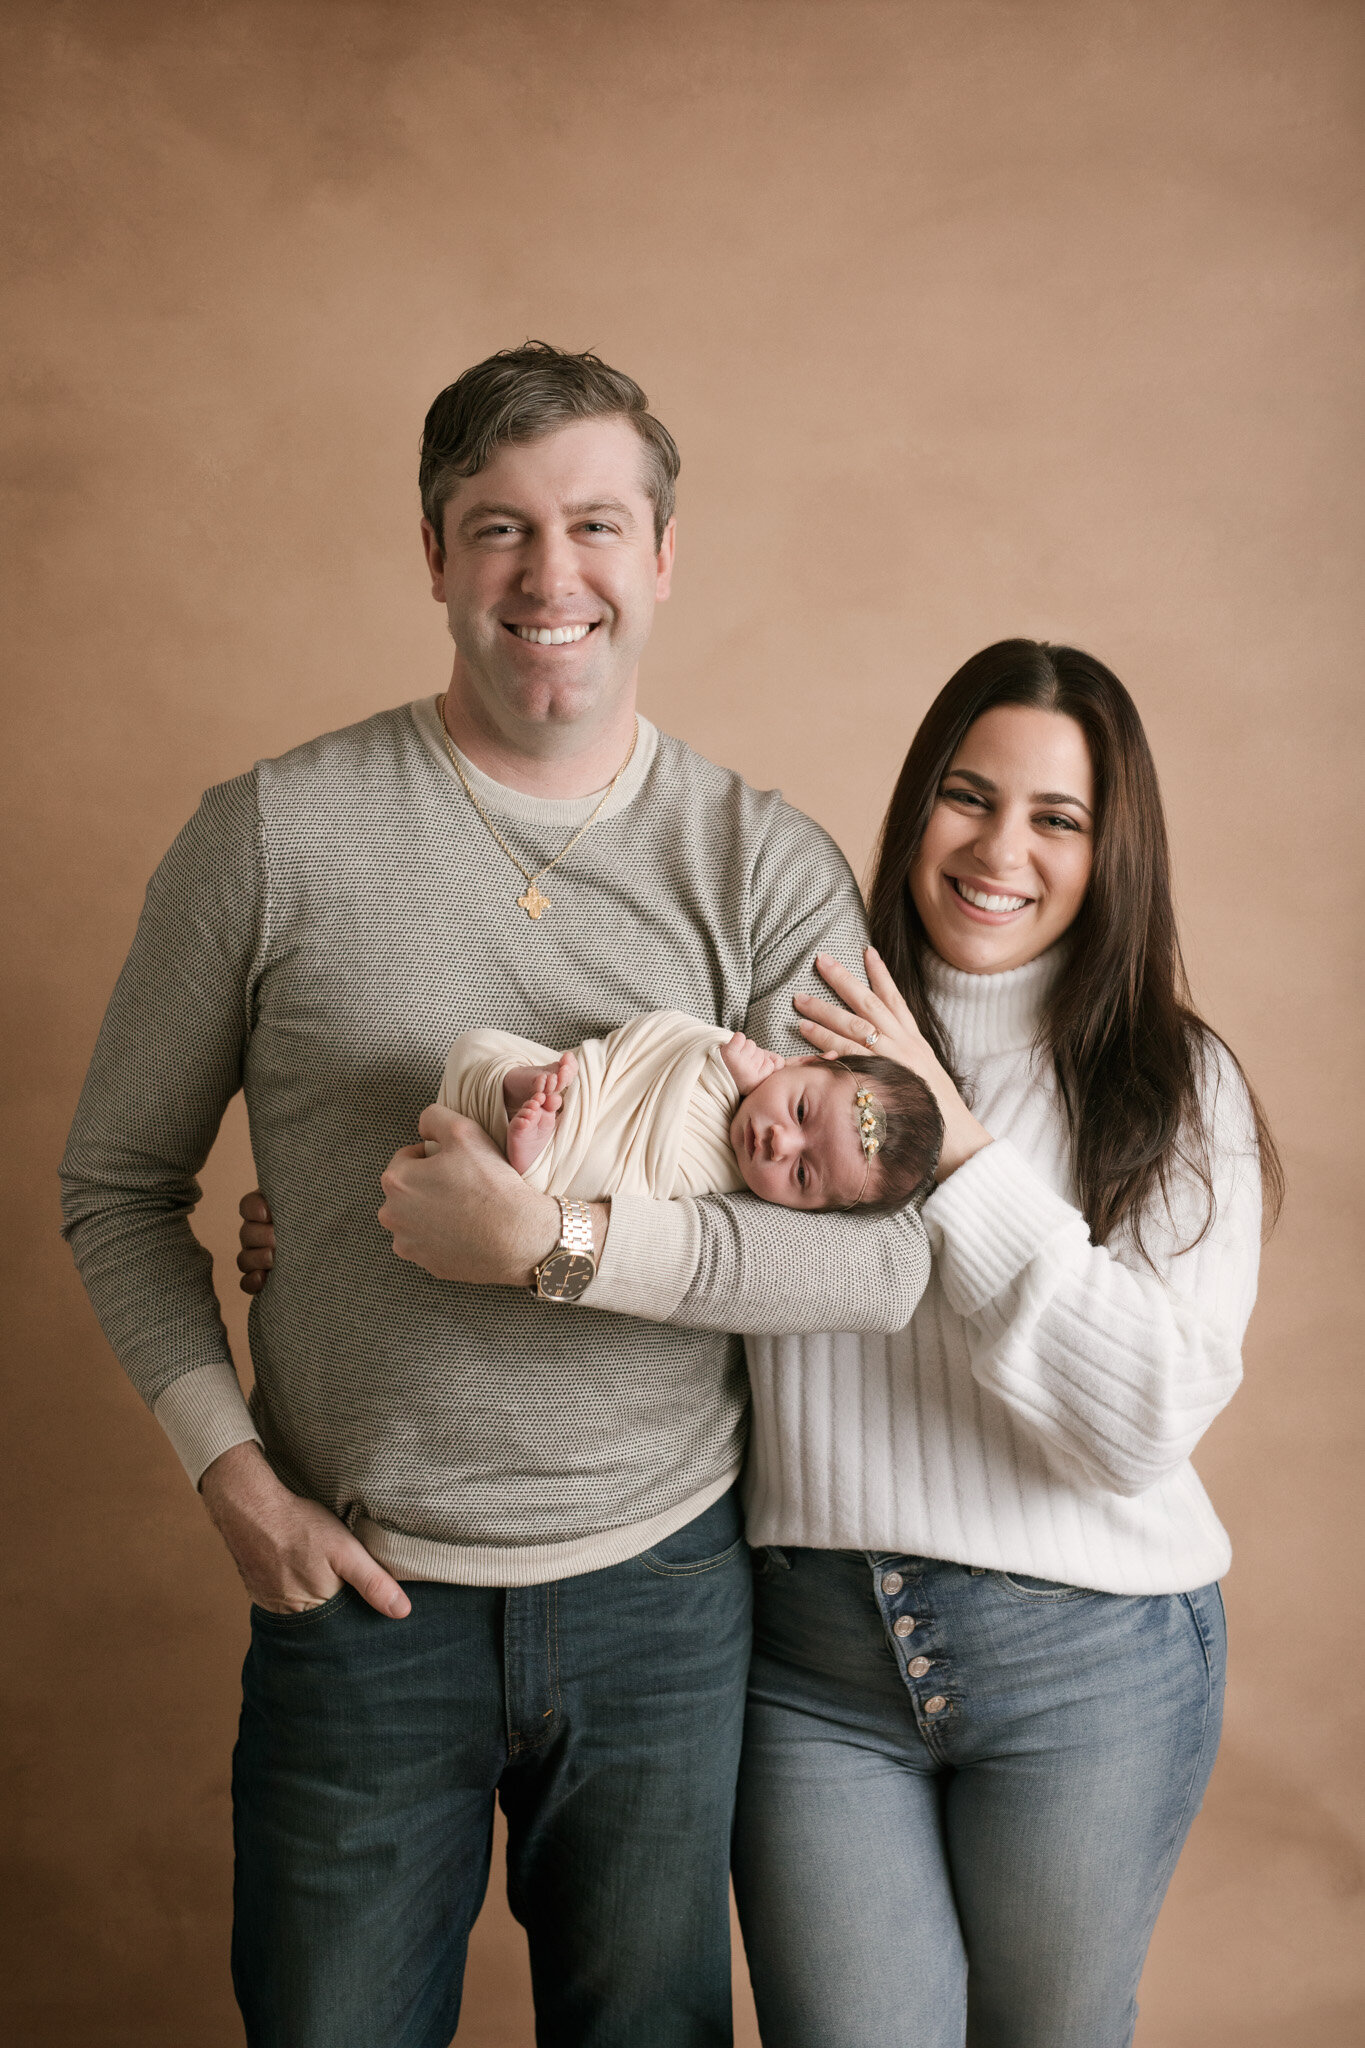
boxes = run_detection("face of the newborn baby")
[731,1059,866,1208]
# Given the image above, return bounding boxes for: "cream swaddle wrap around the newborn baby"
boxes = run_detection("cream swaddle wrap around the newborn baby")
[440,1010,745,1202]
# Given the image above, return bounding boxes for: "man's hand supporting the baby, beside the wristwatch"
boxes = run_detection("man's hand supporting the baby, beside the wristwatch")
[379,1102,606,1286]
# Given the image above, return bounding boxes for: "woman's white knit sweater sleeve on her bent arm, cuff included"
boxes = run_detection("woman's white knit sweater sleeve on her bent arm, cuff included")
[925,1044,1261,1495]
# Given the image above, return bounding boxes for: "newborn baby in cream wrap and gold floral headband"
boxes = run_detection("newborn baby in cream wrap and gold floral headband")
[440,1010,943,1208]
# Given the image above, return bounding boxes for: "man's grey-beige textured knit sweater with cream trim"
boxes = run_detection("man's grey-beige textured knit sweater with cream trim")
[63,702,925,1585]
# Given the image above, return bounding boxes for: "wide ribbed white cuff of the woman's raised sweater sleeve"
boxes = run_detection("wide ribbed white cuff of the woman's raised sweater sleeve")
[923,1139,1089,1315]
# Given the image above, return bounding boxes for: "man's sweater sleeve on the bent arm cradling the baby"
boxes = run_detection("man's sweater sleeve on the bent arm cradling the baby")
[583,805,929,1335]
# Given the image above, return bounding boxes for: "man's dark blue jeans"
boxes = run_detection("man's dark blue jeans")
[233,1493,751,2048]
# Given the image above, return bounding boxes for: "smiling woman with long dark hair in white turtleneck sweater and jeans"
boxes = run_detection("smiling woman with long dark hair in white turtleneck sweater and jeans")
[735,641,1279,2048]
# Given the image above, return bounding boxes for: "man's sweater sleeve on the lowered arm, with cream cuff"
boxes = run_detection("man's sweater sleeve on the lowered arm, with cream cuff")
[61,776,266,1483]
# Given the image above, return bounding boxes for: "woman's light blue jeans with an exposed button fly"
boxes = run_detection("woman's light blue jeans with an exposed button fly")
[735,1550,1226,2048]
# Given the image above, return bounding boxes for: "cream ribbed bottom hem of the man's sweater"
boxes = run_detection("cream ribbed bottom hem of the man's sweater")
[352,1466,739,1587]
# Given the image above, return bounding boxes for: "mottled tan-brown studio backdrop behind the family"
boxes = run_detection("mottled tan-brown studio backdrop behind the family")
[0,0,1365,2048]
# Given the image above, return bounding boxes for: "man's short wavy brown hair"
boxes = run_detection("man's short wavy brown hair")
[417,342,681,547]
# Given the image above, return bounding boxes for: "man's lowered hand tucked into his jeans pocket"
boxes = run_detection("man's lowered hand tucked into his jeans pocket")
[199,1441,411,1620]
